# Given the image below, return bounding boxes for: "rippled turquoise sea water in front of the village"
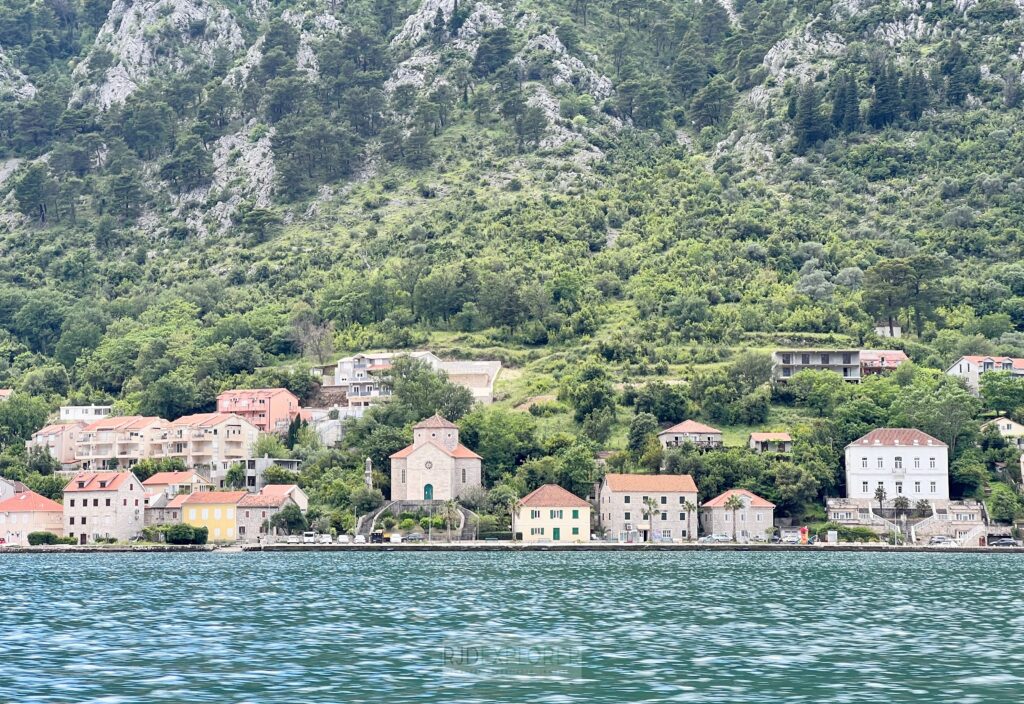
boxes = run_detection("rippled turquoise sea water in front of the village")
[0,553,1024,704]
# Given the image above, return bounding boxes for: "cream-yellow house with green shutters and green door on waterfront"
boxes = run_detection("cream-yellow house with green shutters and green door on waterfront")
[513,484,590,542]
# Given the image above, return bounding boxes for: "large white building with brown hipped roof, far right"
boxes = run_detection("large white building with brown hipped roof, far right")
[846,428,949,504]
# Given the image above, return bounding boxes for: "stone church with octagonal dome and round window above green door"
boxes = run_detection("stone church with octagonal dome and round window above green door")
[391,415,482,501]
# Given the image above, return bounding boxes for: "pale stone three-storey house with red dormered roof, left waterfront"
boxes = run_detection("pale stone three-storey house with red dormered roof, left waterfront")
[63,472,145,545]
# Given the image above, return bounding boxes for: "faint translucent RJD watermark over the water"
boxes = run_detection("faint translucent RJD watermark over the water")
[441,642,584,677]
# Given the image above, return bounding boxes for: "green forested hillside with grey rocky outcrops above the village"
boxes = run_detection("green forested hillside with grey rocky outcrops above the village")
[0,0,1024,521]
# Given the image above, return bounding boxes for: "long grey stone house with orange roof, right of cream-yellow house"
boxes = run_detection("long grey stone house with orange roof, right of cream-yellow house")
[597,474,697,542]
